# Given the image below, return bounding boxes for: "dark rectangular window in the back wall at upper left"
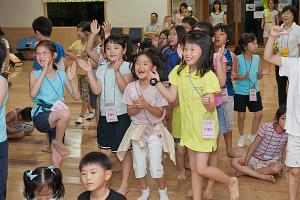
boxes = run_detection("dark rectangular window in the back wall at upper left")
[47,2,104,26]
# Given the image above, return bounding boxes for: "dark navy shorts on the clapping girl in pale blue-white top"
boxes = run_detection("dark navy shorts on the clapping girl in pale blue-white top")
[97,113,131,153]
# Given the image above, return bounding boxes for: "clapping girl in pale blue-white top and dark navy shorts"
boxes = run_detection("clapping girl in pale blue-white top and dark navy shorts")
[78,35,133,194]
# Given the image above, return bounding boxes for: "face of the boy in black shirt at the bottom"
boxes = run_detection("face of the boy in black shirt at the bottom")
[80,164,112,191]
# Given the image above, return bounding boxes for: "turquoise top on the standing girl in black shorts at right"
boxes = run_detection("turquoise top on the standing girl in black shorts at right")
[235,54,260,95]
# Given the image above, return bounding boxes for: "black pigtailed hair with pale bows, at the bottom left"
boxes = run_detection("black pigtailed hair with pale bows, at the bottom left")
[23,166,65,200]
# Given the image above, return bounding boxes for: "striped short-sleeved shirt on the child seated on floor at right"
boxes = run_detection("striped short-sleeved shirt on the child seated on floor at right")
[253,122,288,161]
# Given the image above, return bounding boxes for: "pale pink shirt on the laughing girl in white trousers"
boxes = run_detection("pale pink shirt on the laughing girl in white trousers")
[122,81,168,124]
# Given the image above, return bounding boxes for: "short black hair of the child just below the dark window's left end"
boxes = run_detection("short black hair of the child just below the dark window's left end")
[32,16,52,37]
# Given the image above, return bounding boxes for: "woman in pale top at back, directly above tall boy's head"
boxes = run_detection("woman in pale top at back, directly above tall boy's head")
[209,0,227,26]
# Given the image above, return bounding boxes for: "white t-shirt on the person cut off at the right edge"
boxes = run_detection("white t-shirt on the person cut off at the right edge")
[279,57,300,137]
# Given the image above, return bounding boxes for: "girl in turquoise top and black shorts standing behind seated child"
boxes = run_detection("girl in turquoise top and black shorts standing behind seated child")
[234,33,263,148]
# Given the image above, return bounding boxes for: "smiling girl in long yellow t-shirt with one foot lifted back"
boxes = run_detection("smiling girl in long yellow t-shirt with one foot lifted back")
[151,32,239,200]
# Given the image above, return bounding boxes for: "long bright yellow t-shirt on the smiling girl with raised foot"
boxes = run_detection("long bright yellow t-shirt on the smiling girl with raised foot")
[169,65,220,152]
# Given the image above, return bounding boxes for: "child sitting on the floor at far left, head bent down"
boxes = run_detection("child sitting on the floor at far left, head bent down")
[6,107,34,139]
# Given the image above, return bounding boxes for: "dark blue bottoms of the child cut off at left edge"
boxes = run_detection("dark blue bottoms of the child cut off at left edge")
[0,140,8,200]
